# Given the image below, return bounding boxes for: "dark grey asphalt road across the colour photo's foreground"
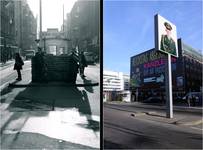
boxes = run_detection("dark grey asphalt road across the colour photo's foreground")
[104,105,202,149]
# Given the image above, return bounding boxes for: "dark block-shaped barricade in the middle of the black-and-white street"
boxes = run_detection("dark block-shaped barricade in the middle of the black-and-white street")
[32,54,78,83]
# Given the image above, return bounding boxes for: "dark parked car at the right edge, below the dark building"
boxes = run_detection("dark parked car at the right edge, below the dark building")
[182,92,202,105]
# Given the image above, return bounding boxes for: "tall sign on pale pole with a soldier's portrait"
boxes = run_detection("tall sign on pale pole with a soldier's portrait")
[155,14,178,118]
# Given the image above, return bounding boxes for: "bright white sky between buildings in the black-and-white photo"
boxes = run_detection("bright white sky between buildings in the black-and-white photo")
[27,0,76,31]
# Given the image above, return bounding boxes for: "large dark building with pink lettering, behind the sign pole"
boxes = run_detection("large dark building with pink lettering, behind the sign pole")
[130,39,203,101]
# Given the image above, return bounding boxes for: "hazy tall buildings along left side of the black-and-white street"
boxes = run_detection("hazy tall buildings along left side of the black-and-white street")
[0,0,37,62]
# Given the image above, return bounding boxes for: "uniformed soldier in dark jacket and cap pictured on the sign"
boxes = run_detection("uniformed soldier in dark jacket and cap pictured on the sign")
[161,22,176,55]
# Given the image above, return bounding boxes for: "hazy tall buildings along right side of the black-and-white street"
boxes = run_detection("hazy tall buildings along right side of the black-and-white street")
[65,0,100,61]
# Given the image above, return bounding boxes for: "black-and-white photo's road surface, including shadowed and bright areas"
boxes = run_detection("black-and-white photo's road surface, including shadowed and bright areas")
[0,62,100,149]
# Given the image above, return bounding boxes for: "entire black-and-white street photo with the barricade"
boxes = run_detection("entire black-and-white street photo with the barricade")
[0,0,101,149]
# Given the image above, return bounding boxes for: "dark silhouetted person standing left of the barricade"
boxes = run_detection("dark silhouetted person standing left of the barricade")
[14,53,24,81]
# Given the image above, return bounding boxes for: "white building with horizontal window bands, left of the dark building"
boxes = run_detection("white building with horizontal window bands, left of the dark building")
[103,70,130,101]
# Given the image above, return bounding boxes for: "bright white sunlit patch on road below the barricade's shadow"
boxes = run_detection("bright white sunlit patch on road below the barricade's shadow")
[21,108,100,148]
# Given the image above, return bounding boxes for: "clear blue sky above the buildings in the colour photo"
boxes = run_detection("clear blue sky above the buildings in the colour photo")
[103,0,202,74]
